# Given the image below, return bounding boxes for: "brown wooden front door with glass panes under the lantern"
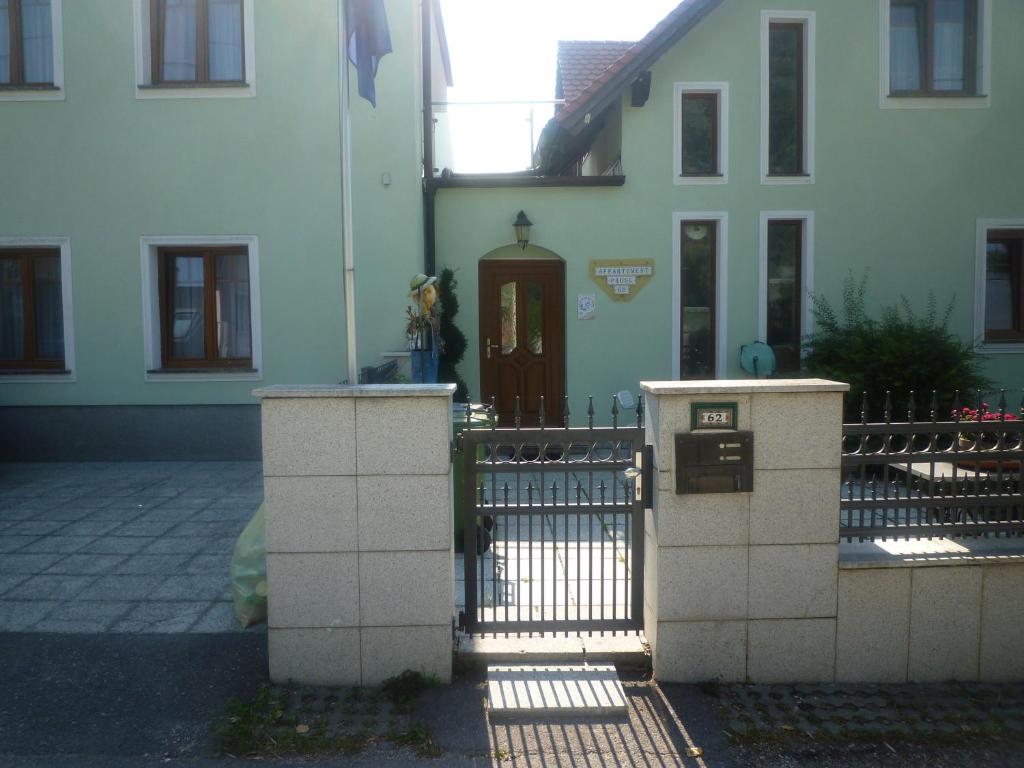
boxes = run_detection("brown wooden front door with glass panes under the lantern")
[480,260,565,427]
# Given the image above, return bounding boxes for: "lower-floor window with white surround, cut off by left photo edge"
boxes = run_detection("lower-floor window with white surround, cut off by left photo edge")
[0,238,75,381]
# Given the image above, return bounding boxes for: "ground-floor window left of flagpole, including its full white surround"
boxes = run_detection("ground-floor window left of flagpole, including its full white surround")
[141,237,261,380]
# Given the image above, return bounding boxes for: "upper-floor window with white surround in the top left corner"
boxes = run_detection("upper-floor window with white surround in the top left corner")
[0,0,63,100]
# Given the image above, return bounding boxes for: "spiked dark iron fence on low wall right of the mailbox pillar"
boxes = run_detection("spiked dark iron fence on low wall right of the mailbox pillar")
[840,390,1024,541]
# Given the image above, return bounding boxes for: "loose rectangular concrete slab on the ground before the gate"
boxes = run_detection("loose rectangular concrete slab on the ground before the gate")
[487,665,626,718]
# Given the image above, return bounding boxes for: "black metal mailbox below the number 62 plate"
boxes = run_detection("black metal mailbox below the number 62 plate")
[676,431,754,494]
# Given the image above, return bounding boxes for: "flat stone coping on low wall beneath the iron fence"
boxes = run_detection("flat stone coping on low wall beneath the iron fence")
[839,539,1024,570]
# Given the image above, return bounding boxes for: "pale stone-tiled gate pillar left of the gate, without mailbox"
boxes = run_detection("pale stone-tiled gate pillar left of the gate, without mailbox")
[254,385,455,685]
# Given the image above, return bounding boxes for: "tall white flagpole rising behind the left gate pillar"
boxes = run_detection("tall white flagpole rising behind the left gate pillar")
[338,0,359,384]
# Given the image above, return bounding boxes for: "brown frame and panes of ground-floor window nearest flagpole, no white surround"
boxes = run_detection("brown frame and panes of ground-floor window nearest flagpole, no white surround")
[160,248,252,369]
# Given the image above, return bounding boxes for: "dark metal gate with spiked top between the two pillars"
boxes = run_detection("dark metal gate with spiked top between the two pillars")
[457,399,652,634]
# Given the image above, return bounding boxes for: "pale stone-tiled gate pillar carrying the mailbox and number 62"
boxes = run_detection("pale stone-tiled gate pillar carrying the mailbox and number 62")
[642,379,847,682]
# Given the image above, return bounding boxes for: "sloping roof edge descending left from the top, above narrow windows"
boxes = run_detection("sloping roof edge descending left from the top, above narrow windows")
[554,0,722,132]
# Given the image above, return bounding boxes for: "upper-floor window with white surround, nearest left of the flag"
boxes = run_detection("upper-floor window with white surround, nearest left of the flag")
[135,0,255,98]
